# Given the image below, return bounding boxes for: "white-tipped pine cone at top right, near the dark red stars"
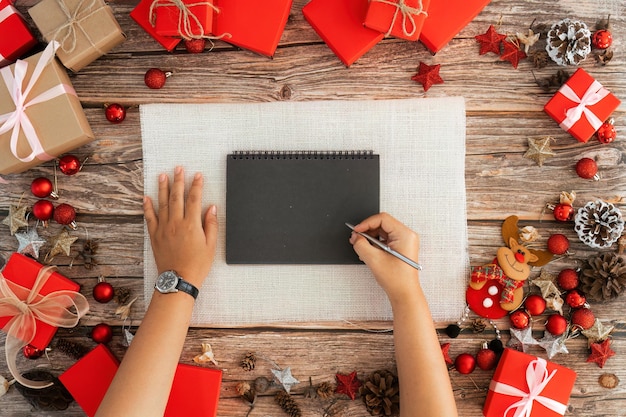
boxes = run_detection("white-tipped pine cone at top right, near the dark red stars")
[546,19,591,65]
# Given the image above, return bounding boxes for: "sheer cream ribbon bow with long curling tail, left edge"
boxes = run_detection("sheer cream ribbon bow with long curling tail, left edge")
[0,267,89,389]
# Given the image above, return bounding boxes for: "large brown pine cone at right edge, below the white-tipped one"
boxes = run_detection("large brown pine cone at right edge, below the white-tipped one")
[580,252,626,301]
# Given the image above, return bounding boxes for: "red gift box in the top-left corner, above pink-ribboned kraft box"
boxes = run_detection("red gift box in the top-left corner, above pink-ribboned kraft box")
[0,0,37,67]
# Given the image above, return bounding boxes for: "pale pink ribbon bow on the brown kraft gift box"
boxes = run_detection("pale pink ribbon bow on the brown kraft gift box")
[0,41,76,162]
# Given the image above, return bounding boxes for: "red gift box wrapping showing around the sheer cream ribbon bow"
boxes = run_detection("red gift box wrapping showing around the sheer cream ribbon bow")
[0,253,80,350]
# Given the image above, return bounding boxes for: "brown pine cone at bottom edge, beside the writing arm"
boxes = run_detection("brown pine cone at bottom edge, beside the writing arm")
[360,370,400,416]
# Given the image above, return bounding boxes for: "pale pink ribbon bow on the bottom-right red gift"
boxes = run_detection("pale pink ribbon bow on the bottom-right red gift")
[489,358,567,417]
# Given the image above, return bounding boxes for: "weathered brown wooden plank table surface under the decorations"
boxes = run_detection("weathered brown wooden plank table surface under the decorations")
[0,0,626,417]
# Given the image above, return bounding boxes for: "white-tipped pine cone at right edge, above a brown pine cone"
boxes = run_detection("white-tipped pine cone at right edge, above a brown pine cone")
[574,200,624,249]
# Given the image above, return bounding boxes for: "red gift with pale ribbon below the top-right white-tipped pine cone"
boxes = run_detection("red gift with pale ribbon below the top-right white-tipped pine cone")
[543,68,621,142]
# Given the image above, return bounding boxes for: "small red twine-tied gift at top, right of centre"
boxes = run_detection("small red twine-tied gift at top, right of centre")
[363,0,430,41]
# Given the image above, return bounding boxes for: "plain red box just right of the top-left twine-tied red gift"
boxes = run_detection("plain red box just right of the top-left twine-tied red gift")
[213,0,292,57]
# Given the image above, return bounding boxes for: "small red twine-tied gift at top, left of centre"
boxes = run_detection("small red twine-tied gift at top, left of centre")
[154,0,216,38]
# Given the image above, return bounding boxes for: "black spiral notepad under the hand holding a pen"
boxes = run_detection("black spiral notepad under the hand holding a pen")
[226,151,380,264]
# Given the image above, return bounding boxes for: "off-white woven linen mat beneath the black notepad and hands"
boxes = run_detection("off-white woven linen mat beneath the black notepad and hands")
[140,97,469,326]
